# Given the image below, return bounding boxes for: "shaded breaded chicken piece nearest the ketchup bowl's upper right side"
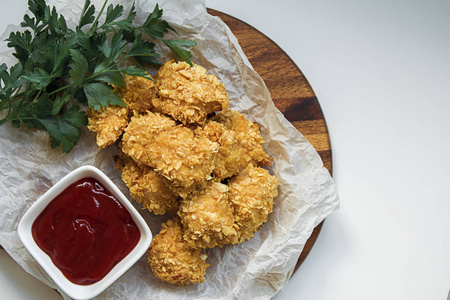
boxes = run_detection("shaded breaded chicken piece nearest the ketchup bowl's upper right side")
[116,152,180,215]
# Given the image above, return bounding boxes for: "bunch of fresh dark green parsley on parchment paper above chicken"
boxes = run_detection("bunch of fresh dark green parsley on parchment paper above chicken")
[0,0,196,153]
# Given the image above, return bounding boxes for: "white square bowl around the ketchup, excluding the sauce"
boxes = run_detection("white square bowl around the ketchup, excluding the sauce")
[18,166,152,299]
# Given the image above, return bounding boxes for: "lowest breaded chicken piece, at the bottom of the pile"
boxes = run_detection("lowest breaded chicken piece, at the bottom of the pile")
[147,218,209,284]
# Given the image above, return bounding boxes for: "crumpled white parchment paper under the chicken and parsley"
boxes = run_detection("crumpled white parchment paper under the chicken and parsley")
[0,0,339,300]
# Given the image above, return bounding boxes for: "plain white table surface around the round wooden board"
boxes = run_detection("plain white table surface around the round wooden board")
[0,0,450,300]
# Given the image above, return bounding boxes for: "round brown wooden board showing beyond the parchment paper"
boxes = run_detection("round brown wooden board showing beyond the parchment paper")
[208,9,332,272]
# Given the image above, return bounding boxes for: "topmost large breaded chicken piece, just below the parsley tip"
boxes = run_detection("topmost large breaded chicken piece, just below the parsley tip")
[153,60,229,124]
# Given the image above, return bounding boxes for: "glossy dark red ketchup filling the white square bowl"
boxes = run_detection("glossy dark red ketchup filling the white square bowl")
[31,178,141,285]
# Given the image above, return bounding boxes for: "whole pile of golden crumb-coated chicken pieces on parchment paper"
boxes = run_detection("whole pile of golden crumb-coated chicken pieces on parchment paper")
[87,61,278,284]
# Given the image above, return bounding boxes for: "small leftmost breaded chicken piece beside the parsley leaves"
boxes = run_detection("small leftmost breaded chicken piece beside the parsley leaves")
[86,105,129,149]
